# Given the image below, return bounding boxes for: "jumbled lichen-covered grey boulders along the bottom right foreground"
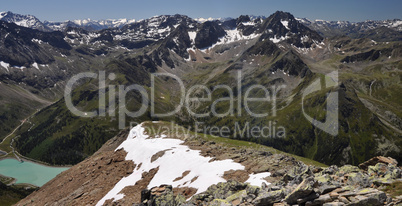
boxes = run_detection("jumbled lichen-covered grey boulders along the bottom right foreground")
[139,157,402,206]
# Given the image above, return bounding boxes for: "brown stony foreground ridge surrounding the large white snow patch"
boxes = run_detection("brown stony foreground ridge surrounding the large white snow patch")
[17,123,402,206]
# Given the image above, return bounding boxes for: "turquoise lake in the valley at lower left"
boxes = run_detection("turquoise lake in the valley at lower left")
[0,159,69,187]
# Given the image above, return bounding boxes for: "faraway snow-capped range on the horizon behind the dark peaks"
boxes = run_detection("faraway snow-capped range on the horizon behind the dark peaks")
[0,11,402,37]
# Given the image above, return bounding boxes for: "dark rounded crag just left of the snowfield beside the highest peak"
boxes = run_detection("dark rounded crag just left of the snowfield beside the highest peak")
[195,21,226,49]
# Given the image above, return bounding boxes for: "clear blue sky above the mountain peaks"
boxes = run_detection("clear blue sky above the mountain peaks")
[0,0,402,22]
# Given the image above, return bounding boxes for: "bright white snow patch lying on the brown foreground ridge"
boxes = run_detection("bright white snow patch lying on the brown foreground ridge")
[97,124,269,205]
